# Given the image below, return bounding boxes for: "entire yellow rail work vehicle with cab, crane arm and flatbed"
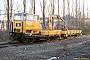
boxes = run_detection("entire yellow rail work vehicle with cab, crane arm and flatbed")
[10,13,82,42]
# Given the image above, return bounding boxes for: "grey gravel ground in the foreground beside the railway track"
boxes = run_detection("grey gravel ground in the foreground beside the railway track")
[0,35,90,60]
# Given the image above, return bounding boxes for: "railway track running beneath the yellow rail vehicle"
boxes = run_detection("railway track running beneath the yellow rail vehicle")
[0,37,80,48]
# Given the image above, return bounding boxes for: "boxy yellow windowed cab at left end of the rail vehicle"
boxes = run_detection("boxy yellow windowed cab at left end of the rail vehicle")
[10,13,40,42]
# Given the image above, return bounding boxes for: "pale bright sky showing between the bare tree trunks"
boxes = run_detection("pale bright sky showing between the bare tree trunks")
[0,0,90,18]
